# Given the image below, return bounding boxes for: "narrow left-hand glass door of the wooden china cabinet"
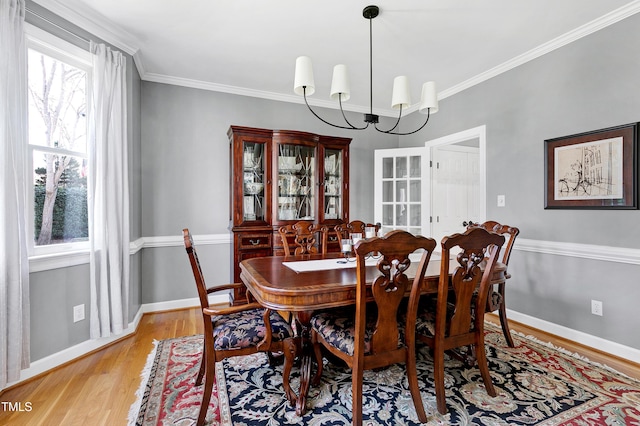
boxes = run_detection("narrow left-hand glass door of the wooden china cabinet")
[242,141,267,221]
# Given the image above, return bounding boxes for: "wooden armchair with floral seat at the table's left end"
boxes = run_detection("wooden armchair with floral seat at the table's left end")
[182,228,297,426]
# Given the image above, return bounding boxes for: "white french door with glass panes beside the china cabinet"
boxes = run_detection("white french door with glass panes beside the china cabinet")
[374,147,429,235]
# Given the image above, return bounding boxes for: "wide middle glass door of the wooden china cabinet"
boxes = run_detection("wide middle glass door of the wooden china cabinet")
[276,144,316,221]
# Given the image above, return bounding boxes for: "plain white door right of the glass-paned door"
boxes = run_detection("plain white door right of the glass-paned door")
[431,145,480,245]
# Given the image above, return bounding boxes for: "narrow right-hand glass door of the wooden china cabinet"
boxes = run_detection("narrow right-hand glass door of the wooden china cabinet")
[322,148,344,220]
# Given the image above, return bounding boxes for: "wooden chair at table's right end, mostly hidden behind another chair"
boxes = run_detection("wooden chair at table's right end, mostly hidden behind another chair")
[467,220,520,348]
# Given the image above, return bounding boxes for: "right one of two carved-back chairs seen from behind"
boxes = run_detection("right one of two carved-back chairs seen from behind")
[407,228,505,414]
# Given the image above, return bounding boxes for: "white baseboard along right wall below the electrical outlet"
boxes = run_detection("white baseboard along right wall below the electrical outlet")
[507,309,640,364]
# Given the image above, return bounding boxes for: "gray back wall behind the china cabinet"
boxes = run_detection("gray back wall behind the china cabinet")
[142,81,398,303]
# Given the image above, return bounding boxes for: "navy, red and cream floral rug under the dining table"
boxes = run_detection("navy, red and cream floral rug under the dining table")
[130,324,640,426]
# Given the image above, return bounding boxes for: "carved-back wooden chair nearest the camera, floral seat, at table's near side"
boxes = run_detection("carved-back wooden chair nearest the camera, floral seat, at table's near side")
[310,230,436,425]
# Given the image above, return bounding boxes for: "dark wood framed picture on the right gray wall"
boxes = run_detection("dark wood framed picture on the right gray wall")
[544,123,638,209]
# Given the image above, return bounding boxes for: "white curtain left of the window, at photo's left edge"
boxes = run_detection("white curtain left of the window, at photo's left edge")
[0,0,29,389]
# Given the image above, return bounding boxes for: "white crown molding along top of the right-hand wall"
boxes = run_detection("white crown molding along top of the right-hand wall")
[438,0,640,100]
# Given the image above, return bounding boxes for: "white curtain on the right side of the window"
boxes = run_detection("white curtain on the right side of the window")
[87,42,129,339]
